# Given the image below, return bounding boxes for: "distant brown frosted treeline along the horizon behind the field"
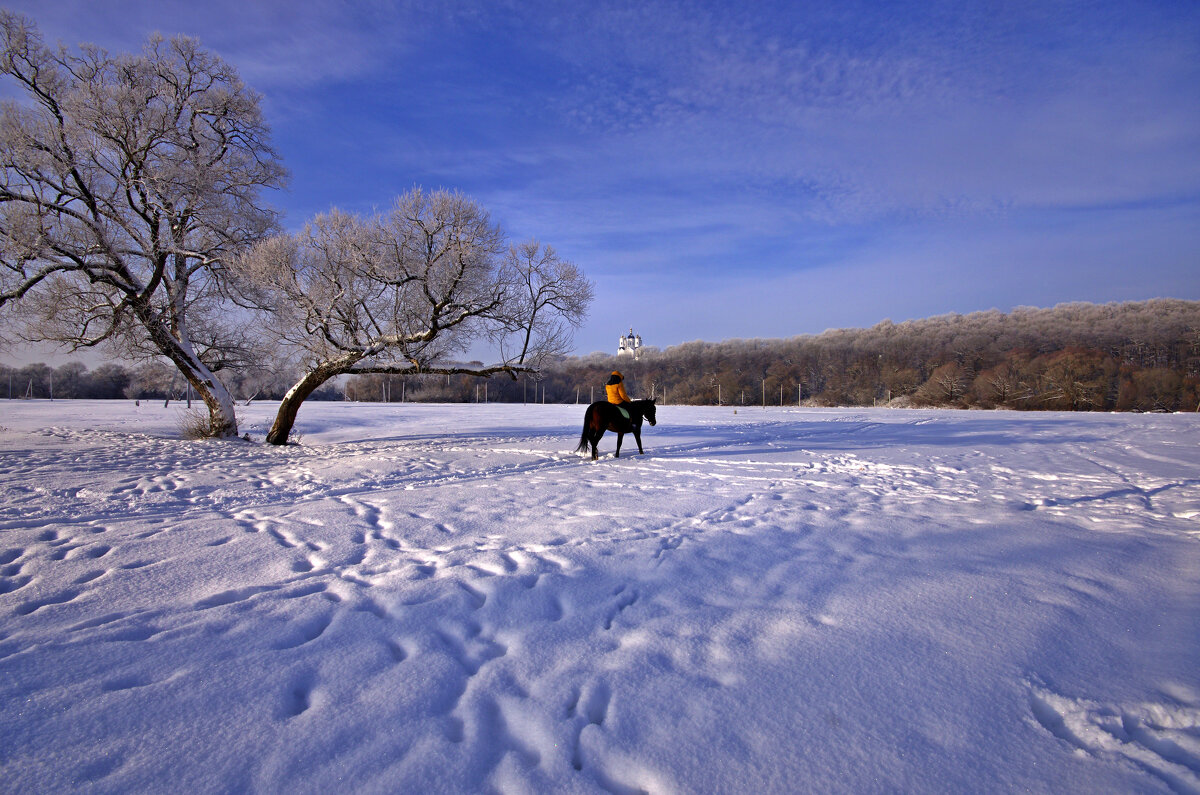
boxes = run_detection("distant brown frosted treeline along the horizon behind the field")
[9,299,1200,411]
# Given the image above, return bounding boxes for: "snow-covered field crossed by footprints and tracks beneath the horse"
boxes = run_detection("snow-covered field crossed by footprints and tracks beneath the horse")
[0,401,1200,793]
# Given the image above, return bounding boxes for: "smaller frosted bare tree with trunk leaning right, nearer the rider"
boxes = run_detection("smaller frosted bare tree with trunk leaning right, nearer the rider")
[234,190,592,444]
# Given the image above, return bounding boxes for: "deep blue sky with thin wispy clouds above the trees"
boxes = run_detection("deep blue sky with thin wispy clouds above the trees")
[0,0,1200,354]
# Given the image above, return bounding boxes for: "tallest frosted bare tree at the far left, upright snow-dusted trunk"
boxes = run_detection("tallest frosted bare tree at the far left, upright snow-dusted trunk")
[0,11,286,437]
